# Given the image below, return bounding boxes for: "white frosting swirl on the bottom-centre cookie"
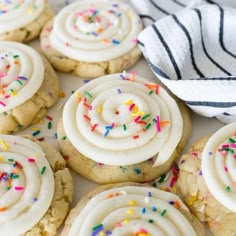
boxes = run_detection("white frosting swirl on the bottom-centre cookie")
[68,186,197,236]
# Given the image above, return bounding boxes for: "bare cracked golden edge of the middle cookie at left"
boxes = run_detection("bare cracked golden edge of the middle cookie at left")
[0,54,59,134]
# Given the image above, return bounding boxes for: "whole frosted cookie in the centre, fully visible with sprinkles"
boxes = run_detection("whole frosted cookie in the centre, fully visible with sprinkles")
[58,74,191,183]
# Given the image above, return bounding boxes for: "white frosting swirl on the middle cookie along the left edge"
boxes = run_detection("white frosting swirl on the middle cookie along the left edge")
[0,42,44,112]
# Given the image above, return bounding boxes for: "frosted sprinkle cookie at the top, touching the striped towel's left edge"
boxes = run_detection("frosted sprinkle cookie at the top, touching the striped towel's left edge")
[41,0,142,77]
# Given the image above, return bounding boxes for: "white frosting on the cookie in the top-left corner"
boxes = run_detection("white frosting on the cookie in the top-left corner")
[0,0,45,34]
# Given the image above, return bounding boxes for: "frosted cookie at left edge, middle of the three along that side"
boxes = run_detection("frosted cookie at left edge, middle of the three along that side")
[0,41,59,133]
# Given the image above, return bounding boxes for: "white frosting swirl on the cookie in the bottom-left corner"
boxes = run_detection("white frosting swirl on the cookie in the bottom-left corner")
[0,135,54,236]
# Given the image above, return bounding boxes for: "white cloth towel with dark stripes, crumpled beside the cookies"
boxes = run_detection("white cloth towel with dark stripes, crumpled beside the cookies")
[131,0,236,123]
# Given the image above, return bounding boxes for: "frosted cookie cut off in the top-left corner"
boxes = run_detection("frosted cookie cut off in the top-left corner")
[0,0,53,42]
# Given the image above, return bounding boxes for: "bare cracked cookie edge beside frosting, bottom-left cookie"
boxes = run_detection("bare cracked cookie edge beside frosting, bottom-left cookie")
[24,139,73,236]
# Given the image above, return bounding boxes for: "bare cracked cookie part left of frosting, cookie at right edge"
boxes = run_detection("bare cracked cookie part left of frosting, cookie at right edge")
[177,136,236,236]
